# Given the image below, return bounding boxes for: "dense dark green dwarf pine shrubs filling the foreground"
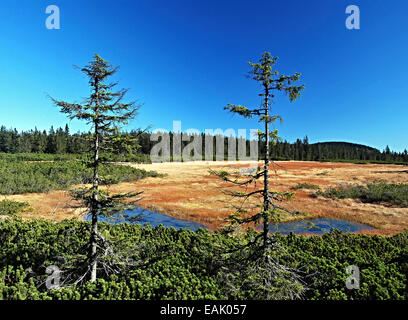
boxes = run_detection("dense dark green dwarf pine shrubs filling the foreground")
[0,218,408,300]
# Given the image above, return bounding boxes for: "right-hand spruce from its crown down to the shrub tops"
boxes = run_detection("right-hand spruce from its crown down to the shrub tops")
[214,52,304,247]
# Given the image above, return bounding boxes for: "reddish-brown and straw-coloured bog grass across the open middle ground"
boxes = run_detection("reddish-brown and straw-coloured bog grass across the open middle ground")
[8,161,408,235]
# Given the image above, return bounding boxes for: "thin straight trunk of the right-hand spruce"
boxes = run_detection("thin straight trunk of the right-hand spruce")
[263,87,269,247]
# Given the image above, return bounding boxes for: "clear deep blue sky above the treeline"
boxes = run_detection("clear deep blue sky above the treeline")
[0,0,408,151]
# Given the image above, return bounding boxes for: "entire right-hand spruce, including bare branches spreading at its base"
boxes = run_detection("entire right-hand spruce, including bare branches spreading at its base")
[212,52,304,299]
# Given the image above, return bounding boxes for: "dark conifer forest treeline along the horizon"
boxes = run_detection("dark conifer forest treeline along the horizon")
[0,125,408,163]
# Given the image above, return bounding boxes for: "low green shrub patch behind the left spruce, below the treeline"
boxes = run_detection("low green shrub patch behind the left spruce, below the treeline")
[0,160,158,195]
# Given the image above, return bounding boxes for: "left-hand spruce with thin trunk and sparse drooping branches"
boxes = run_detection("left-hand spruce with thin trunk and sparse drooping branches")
[51,54,141,282]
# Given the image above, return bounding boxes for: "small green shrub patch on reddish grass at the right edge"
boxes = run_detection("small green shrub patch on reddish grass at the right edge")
[318,181,408,207]
